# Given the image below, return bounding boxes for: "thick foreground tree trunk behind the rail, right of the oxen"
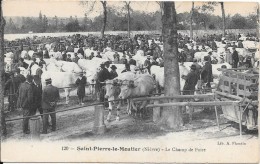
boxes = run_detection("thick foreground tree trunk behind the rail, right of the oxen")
[159,2,183,130]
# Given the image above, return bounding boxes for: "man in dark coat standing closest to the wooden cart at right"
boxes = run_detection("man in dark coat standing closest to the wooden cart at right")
[201,56,212,88]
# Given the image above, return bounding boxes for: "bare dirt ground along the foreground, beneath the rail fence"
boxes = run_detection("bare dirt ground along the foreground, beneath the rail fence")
[4,93,258,141]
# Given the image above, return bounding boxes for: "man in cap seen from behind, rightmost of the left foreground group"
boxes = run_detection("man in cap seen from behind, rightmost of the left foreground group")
[42,78,60,134]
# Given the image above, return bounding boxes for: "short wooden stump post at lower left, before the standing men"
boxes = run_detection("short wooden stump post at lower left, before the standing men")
[29,117,41,140]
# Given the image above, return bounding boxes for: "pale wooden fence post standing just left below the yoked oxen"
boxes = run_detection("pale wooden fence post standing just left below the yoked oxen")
[92,105,106,134]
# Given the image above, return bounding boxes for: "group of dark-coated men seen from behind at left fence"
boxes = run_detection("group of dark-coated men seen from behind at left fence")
[5,68,59,134]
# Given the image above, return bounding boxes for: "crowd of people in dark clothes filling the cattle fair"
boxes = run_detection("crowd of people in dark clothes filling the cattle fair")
[5,31,258,134]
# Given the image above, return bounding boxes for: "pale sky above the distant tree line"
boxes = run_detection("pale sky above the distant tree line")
[3,0,257,18]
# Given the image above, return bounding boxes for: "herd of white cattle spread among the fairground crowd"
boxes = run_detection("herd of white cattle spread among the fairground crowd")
[5,34,260,120]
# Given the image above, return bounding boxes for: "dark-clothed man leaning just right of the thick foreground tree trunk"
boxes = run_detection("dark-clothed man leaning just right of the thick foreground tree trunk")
[182,65,198,95]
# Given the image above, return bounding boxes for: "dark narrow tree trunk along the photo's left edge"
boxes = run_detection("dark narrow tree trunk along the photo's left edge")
[0,1,6,135]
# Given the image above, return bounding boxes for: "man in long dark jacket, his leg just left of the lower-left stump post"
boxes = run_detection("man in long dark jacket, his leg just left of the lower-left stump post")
[17,75,33,134]
